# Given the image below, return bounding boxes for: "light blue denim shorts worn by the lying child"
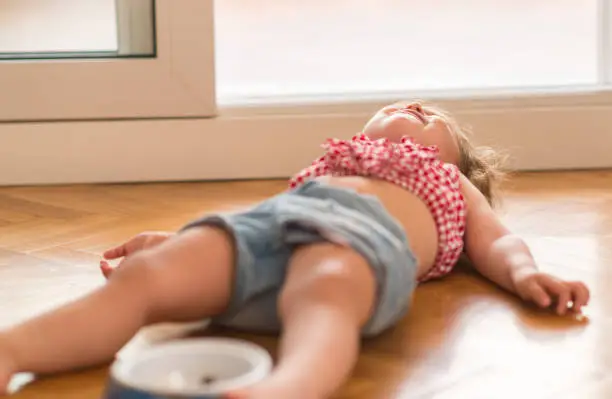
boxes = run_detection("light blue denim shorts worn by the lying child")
[179,180,417,336]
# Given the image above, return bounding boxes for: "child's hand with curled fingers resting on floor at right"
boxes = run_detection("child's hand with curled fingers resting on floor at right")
[514,271,590,315]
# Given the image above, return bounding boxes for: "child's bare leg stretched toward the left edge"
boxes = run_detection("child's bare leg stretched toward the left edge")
[0,227,234,392]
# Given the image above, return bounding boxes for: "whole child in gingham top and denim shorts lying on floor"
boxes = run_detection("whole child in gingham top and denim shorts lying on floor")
[0,102,589,399]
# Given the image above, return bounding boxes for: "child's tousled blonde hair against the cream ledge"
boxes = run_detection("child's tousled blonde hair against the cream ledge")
[423,101,506,206]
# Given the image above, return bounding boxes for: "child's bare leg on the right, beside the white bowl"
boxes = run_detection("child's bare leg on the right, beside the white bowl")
[229,244,376,399]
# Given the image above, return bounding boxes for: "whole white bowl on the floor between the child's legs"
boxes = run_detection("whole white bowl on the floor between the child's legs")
[106,338,272,398]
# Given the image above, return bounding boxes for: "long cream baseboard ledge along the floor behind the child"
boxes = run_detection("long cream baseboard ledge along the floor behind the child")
[0,105,612,185]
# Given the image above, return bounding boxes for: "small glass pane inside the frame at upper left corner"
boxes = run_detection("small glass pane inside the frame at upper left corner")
[0,0,154,59]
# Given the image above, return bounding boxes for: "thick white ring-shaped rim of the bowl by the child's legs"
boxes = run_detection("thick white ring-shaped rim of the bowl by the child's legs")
[110,338,273,396]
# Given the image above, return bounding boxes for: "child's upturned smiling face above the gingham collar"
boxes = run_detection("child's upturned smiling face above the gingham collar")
[363,102,460,164]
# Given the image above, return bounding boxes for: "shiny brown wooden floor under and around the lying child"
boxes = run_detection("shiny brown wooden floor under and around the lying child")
[0,172,612,399]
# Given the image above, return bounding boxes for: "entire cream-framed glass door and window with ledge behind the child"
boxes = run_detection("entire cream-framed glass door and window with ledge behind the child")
[0,0,612,184]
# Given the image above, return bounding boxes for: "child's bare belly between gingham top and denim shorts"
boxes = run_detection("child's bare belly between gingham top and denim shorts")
[317,176,438,276]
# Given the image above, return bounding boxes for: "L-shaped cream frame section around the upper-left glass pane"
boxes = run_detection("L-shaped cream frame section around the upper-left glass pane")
[0,0,217,122]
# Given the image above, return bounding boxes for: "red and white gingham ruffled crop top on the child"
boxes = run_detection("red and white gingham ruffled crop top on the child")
[289,134,466,281]
